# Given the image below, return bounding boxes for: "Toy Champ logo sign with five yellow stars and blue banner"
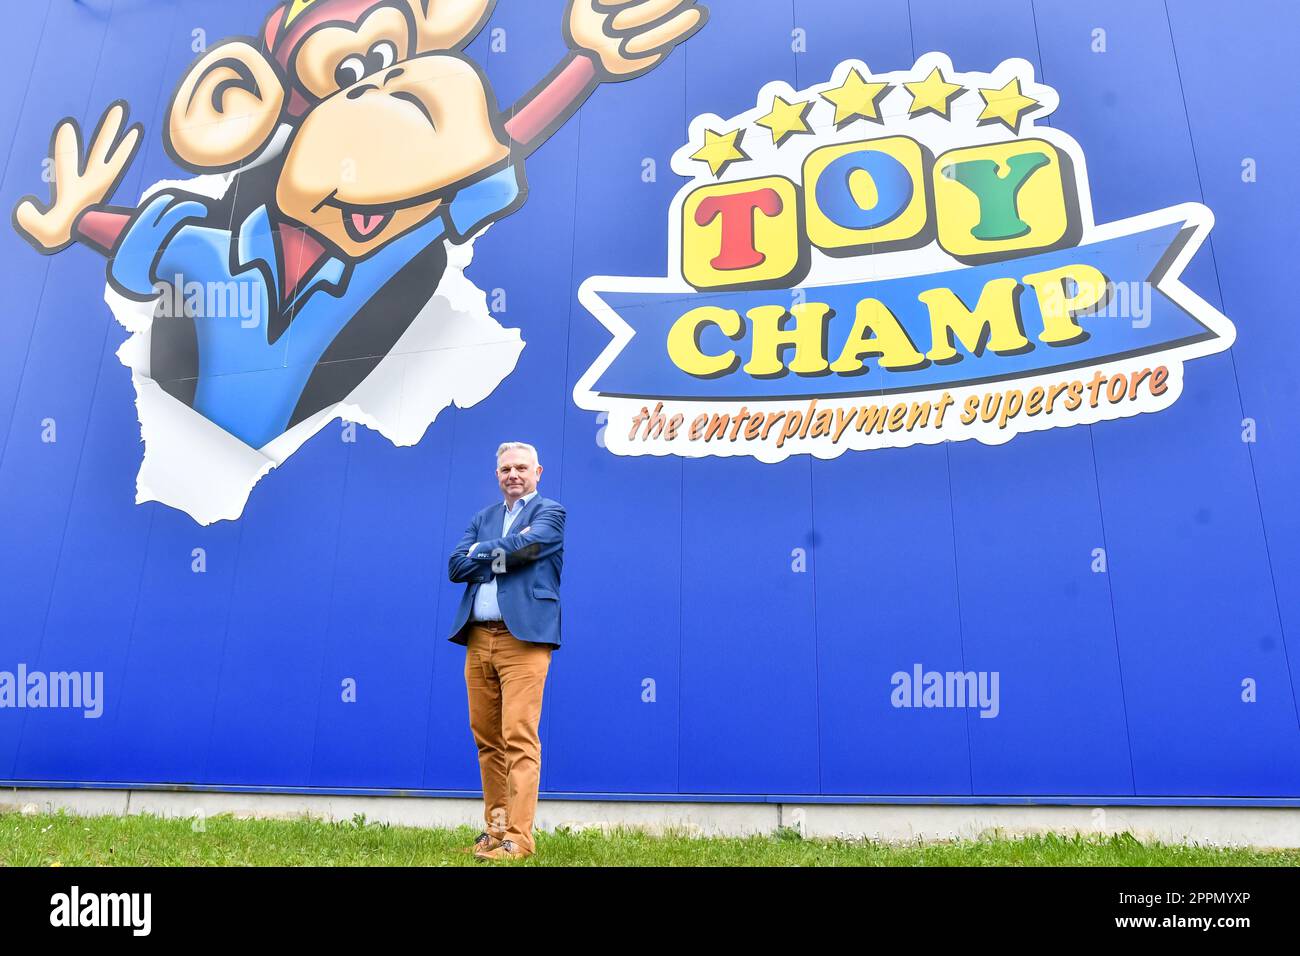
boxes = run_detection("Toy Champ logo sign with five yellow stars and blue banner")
[573,53,1235,462]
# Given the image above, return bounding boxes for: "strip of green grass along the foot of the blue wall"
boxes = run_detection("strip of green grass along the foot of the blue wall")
[0,813,1300,866]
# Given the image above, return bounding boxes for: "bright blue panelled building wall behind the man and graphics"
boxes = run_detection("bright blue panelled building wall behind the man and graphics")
[0,0,1300,803]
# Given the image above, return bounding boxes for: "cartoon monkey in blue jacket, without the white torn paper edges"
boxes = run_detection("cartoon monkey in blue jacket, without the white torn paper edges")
[13,0,707,447]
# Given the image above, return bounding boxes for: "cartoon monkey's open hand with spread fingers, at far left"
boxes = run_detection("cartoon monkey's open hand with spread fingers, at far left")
[13,101,142,255]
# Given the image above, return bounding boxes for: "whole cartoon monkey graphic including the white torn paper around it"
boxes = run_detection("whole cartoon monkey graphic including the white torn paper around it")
[5,0,707,524]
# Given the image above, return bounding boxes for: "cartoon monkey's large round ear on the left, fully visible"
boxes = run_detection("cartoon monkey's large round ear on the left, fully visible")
[163,40,285,173]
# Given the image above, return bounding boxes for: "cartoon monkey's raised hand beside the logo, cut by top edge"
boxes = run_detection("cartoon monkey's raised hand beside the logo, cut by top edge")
[566,0,709,81]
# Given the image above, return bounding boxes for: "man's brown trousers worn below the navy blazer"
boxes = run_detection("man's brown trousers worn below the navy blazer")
[465,622,553,853]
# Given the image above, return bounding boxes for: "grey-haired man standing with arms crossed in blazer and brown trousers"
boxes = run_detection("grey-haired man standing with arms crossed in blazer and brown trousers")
[449,441,564,860]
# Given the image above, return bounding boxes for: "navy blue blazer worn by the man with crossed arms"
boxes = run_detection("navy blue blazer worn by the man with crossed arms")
[447,494,564,648]
